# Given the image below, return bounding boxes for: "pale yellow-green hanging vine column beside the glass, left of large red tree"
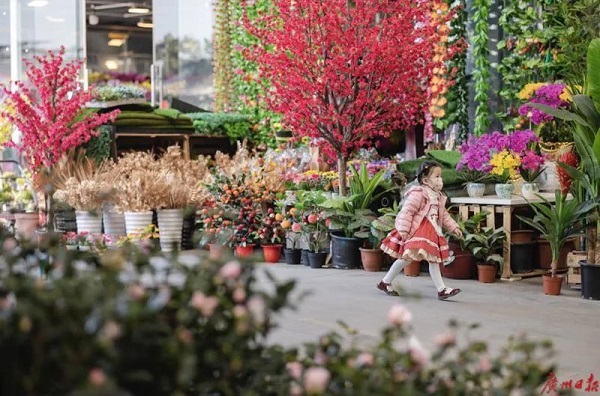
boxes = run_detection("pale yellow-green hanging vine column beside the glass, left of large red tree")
[213,0,238,111]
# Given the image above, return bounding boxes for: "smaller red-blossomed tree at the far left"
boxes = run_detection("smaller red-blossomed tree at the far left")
[1,47,119,227]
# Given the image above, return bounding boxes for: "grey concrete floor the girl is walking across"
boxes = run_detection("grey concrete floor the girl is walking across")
[262,263,600,392]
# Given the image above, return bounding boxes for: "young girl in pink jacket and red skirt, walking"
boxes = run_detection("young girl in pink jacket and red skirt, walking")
[377,161,462,300]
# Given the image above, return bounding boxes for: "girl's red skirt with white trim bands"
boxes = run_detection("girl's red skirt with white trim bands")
[380,219,450,263]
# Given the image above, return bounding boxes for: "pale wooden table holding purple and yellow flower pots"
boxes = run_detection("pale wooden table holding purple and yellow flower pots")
[450,193,555,280]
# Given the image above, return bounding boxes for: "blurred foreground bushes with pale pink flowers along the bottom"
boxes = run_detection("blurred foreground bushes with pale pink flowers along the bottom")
[0,230,554,396]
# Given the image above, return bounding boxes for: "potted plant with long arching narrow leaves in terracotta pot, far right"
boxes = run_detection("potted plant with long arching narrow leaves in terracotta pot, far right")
[517,190,598,295]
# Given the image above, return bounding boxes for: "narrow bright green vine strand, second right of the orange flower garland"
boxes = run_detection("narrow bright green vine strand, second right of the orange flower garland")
[472,0,490,136]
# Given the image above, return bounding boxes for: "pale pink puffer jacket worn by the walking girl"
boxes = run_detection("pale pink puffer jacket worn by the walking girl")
[395,186,458,241]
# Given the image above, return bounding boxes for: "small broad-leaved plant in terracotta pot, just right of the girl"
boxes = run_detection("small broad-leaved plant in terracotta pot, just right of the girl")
[464,227,506,283]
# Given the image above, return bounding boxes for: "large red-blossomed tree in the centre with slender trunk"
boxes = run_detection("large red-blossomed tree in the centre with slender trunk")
[244,0,446,195]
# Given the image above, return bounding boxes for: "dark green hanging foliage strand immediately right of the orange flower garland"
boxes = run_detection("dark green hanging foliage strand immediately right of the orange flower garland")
[434,0,469,141]
